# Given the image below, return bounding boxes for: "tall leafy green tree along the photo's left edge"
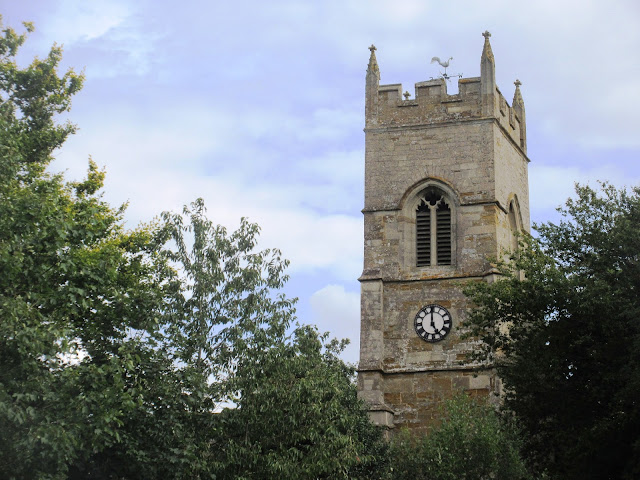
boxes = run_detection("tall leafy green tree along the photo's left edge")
[0,19,174,478]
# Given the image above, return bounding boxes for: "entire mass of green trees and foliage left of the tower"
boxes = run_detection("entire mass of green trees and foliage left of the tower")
[0,19,386,479]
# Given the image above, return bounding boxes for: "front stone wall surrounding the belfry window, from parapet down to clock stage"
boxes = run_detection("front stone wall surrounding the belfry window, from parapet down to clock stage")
[364,121,504,279]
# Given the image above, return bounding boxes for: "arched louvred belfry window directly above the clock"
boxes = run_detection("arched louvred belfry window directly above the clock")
[416,189,452,267]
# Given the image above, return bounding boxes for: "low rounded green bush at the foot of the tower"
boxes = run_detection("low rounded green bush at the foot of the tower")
[389,395,530,480]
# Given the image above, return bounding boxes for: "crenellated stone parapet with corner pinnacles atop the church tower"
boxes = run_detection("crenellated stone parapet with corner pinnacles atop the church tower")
[365,32,527,154]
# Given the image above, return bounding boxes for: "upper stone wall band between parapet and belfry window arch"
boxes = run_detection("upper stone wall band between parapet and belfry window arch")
[364,119,494,211]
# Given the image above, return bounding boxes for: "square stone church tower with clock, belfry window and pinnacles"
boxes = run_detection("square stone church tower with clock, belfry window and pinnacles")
[358,32,529,429]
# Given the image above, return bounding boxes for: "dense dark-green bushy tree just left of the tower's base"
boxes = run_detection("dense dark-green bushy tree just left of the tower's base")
[215,327,385,479]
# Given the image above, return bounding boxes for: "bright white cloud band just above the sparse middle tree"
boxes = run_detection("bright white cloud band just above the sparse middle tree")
[117,169,362,280]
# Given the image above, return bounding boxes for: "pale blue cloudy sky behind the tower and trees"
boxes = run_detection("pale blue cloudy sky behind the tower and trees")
[0,0,640,362]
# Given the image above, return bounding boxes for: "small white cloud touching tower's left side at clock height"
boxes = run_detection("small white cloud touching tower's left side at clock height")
[309,285,360,363]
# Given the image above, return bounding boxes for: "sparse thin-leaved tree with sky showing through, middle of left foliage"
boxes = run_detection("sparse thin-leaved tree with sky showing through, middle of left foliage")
[65,199,302,479]
